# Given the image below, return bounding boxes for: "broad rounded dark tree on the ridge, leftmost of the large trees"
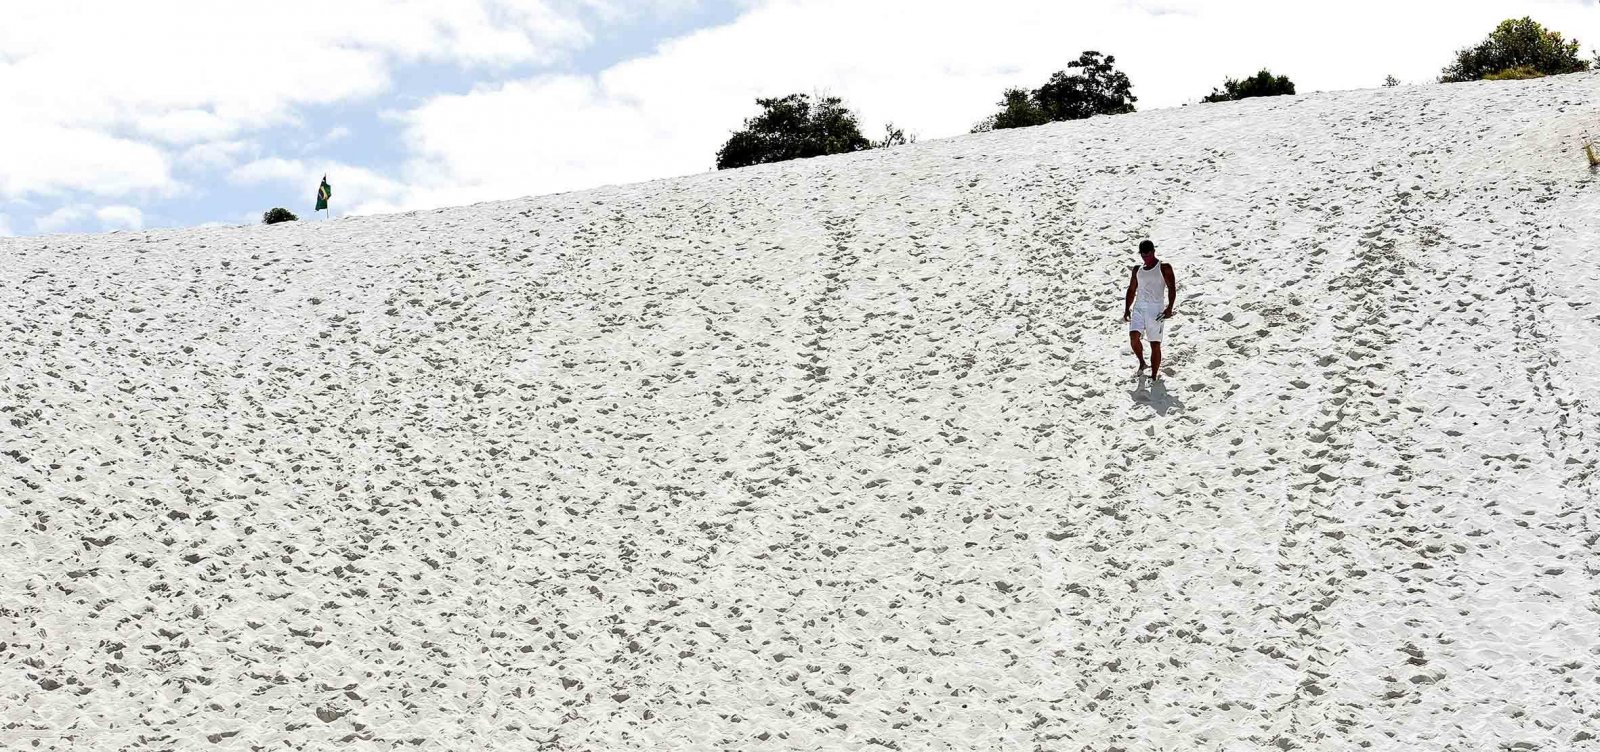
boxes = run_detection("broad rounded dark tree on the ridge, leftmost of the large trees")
[717,94,872,170]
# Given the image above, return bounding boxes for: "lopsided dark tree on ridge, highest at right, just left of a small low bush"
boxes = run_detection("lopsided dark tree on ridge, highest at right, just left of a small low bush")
[973,50,1139,133]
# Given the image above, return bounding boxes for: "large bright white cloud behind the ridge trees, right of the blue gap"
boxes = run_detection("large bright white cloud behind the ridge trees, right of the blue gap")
[380,0,1600,208]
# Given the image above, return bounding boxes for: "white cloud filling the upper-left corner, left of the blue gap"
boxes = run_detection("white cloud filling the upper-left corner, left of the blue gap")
[0,0,665,197]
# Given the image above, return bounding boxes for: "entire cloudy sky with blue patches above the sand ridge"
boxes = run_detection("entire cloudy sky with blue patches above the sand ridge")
[0,0,1600,235]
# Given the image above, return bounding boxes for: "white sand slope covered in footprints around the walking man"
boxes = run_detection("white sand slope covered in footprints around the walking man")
[9,75,1600,750]
